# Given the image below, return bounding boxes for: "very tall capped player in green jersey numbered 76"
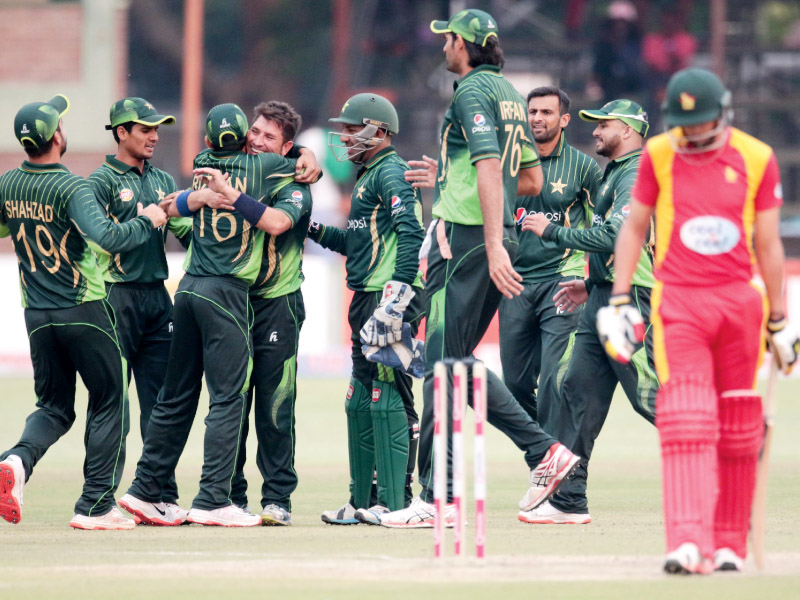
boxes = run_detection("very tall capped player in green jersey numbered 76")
[380,9,578,528]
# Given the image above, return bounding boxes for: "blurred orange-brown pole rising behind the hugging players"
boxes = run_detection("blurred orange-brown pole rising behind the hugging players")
[181,0,203,177]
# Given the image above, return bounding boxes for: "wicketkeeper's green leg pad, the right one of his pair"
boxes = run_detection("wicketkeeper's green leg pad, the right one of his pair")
[370,381,409,510]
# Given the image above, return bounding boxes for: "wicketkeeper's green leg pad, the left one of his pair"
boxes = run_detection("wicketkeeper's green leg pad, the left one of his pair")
[344,379,375,508]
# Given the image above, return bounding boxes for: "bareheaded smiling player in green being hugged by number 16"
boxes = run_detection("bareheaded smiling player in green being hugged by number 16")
[225,100,312,525]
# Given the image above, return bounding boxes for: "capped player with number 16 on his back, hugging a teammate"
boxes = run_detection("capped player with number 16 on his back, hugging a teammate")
[120,104,295,527]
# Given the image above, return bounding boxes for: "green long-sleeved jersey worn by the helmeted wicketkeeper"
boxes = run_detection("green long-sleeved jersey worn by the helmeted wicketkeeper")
[318,146,425,292]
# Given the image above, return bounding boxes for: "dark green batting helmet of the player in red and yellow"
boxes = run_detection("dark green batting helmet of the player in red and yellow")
[661,68,731,127]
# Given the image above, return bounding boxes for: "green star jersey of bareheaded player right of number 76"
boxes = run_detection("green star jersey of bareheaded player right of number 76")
[514,137,603,283]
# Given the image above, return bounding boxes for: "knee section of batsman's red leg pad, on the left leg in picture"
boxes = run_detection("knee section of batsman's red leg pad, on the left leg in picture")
[656,375,717,447]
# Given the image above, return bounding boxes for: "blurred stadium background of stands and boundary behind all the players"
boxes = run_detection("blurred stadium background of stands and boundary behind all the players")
[0,0,800,376]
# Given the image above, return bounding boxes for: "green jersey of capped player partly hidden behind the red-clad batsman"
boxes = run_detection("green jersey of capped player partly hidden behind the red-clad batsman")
[542,150,655,288]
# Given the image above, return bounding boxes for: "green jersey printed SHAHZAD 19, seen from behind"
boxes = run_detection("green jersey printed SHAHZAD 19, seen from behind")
[0,161,153,309]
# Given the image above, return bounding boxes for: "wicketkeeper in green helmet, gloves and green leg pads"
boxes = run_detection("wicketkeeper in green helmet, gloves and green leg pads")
[309,93,425,525]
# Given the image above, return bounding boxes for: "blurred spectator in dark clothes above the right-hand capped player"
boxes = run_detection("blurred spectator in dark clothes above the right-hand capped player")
[586,0,646,102]
